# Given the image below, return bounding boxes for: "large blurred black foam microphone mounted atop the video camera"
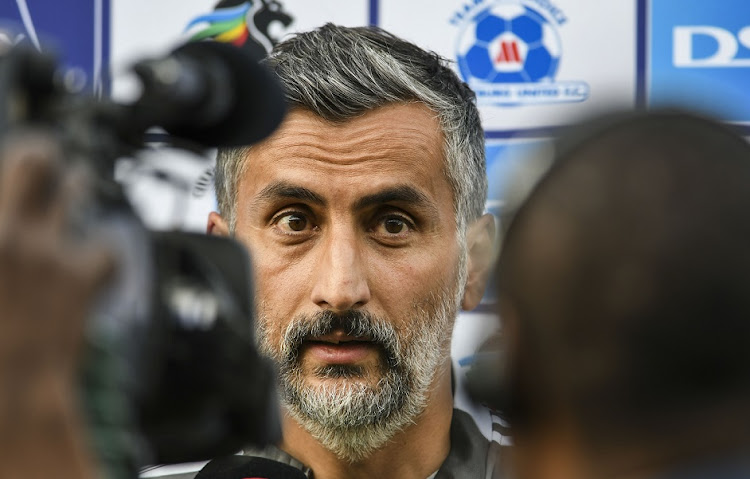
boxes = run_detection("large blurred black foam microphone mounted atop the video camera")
[132,41,286,147]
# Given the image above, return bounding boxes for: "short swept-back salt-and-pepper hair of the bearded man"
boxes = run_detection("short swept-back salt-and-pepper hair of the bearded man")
[216,23,487,233]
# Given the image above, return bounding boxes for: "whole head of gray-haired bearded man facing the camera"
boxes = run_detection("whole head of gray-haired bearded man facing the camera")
[209,25,492,462]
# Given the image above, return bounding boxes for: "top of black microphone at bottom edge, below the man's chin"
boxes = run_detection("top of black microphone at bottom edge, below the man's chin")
[195,456,307,479]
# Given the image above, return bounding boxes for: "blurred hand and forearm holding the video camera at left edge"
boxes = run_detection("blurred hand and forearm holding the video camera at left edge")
[0,132,113,479]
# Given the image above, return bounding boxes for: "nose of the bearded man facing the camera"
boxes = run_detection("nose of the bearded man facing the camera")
[311,232,370,311]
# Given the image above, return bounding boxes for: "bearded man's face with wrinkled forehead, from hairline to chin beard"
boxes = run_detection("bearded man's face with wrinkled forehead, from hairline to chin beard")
[214,104,465,459]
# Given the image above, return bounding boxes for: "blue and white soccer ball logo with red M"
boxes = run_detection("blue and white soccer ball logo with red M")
[458,3,561,83]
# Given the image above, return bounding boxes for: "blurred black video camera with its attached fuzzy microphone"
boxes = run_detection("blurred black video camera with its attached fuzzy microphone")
[0,42,284,478]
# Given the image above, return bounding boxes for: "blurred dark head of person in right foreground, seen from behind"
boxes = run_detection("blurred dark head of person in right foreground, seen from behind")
[498,112,750,479]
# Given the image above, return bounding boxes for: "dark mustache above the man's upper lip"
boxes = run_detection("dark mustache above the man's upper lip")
[281,310,401,368]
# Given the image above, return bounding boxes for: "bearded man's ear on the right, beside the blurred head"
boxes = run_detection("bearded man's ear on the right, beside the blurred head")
[461,214,495,311]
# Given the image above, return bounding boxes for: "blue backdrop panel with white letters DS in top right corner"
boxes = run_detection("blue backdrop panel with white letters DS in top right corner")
[646,0,750,124]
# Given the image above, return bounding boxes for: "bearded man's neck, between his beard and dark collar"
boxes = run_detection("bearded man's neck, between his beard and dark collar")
[281,368,453,479]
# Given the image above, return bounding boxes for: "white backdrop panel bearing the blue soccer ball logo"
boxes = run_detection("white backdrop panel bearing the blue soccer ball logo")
[379,0,637,132]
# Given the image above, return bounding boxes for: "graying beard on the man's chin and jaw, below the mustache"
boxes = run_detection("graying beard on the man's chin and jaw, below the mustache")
[281,291,457,463]
